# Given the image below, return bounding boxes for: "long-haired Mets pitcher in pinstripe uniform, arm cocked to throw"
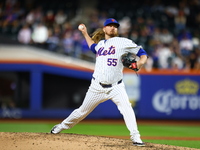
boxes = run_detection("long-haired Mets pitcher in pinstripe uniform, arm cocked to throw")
[51,18,147,146]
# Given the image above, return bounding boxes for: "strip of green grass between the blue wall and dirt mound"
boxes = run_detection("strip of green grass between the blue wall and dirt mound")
[0,121,200,149]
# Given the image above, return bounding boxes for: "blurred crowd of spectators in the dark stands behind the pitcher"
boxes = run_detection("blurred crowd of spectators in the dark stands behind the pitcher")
[0,0,200,70]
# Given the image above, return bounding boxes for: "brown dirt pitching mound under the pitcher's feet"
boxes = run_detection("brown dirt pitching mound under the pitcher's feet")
[0,132,195,150]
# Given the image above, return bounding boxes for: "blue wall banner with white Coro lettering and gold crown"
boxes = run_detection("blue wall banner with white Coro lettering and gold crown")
[138,75,200,119]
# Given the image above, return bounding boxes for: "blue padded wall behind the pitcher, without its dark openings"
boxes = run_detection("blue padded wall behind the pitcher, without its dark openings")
[0,63,200,119]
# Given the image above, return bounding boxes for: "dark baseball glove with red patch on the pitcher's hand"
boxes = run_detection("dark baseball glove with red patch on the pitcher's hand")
[121,53,139,71]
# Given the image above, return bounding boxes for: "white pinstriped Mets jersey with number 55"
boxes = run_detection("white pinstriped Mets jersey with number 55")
[93,37,141,84]
